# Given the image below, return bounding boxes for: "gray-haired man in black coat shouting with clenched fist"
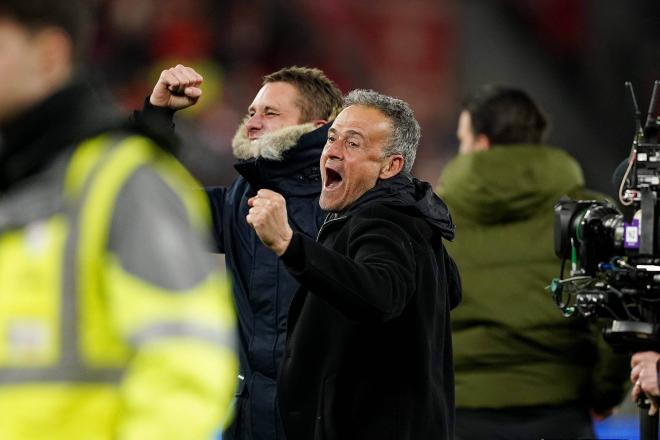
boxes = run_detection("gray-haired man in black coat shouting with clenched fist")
[247,90,460,440]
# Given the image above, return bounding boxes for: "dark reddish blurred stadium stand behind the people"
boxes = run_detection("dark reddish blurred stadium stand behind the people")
[93,0,660,194]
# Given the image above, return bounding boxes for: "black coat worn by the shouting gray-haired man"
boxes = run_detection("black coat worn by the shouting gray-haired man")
[278,175,460,440]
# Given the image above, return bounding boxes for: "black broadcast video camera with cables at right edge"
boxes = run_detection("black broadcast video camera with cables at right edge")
[550,81,660,353]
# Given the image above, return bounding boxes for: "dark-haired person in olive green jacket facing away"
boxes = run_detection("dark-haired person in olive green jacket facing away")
[439,85,627,440]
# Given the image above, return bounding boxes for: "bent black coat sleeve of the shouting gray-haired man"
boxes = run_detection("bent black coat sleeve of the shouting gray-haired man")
[282,214,415,321]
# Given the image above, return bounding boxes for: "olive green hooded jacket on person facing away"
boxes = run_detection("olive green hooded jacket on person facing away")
[439,145,629,410]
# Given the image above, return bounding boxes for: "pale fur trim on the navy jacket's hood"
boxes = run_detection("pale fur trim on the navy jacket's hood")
[232,121,317,161]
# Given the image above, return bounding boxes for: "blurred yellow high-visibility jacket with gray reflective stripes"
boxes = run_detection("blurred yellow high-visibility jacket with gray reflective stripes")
[0,134,237,440]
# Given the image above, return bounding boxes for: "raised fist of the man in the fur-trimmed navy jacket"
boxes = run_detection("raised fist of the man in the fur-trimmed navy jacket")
[149,64,204,110]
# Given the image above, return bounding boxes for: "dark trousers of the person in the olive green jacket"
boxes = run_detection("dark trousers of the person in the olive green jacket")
[455,406,595,440]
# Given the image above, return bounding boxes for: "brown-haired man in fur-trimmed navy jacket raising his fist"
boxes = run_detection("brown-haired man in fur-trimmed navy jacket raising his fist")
[135,65,342,440]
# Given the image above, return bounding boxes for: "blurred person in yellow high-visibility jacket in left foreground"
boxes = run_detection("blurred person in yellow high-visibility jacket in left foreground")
[0,0,238,440]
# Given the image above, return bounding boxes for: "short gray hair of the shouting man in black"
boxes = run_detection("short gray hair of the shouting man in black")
[342,89,421,173]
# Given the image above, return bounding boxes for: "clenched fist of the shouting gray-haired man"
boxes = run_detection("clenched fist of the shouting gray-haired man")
[245,189,293,256]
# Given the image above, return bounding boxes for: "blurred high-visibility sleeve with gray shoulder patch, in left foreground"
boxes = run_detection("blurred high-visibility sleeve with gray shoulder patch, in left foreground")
[104,168,237,440]
